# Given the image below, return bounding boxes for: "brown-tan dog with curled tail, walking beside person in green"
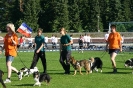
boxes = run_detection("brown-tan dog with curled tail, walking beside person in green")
[69,57,91,75]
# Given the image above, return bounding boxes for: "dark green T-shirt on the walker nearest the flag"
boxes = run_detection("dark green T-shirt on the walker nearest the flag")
[35,35,45,51]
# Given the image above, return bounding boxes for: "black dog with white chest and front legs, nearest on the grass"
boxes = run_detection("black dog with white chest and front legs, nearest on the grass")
[33,72,51,86]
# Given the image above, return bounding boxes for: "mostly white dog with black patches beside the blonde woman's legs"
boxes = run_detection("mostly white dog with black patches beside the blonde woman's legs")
[18,67,39,80]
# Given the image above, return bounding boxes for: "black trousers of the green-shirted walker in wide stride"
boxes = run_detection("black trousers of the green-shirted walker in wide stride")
[30,51,47,73]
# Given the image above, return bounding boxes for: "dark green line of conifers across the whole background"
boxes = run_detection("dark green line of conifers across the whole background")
[0,0,133,32]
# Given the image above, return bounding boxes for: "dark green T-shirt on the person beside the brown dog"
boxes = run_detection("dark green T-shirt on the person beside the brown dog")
[60,34,71,50]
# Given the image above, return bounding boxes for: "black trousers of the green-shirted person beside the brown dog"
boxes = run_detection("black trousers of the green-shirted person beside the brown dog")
[59,50,71,74]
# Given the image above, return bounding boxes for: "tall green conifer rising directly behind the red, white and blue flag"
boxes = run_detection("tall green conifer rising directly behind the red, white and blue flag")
[19,0,41,32]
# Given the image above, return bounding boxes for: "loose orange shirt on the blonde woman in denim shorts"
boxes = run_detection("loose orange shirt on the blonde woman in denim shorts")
[4,33,18,56]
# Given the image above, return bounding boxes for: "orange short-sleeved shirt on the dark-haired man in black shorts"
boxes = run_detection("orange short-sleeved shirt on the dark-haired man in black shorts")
[107,32,121,49]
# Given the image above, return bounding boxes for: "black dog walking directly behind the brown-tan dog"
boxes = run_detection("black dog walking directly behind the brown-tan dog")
[89,57,103,72]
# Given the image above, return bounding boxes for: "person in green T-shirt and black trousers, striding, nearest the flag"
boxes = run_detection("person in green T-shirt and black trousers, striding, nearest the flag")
[30,28,46,73]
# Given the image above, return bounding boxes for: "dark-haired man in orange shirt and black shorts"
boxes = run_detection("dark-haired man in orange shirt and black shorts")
[106,24,122,73]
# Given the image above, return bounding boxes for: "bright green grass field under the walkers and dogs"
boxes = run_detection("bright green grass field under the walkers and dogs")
[0,51,133,88]
